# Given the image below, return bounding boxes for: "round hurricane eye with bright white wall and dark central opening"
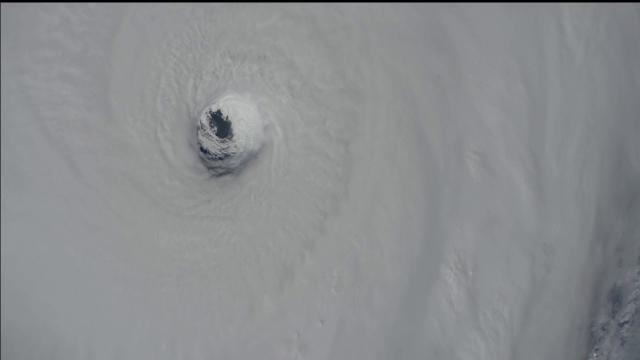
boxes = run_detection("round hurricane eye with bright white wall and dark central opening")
[198,94,265,175]
